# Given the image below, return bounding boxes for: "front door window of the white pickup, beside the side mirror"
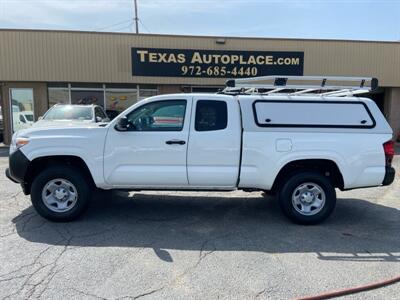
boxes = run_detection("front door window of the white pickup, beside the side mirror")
[126,100,186,131]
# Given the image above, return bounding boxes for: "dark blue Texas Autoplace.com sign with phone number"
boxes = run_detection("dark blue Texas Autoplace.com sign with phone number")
[132,48,304,78]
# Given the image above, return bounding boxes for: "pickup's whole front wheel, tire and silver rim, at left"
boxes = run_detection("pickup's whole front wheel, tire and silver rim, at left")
[31,166,91,222]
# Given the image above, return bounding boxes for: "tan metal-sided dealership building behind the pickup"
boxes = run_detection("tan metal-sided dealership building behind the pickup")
[0,29,400,143]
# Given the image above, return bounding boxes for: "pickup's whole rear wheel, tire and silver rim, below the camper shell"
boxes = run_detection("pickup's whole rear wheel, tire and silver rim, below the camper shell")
[279,172,336,225]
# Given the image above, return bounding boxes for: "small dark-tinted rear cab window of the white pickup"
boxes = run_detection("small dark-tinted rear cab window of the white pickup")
[194,100,228,131]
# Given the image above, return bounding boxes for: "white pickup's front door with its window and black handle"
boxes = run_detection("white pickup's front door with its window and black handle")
[104,97,192,188]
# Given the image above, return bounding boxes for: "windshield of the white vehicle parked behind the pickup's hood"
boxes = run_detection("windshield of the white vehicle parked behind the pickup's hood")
[43,105,93,121]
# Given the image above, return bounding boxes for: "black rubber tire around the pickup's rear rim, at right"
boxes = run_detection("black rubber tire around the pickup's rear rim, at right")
[279,171,336,225]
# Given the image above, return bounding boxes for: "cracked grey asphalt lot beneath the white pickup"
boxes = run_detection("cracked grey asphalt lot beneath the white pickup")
[0,149,400,299]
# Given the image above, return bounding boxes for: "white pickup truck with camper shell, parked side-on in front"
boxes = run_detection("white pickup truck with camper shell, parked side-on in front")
[6,78,395,224]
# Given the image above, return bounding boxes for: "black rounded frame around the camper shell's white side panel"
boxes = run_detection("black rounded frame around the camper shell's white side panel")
[252,99,376,129]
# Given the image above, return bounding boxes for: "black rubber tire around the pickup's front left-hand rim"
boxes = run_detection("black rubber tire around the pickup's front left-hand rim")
[31,166,92,222]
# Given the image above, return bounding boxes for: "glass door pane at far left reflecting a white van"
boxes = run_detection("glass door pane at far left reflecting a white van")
[10,88,34,132]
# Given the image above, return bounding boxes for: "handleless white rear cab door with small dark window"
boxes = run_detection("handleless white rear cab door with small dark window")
[187,94,242,189]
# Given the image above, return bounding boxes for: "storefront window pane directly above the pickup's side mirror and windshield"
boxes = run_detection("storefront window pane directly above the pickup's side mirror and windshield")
[106,89,137,114]
